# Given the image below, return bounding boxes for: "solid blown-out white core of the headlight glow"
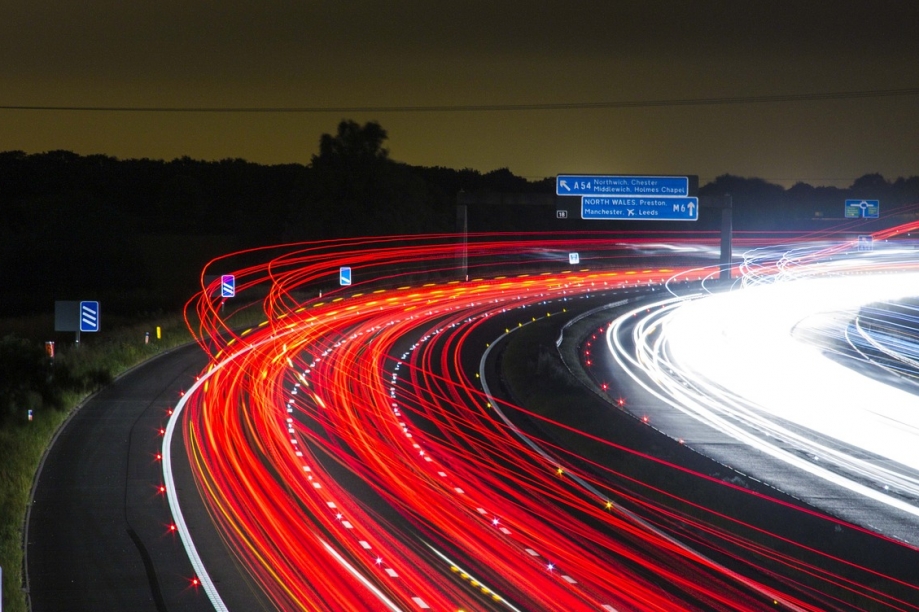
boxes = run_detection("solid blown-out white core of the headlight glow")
[667,274,919,468]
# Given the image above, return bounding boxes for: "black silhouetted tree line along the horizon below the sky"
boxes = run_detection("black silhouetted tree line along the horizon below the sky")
[0,121,919,314]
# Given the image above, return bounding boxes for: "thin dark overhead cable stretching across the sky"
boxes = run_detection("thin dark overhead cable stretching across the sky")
[0,87,919,114]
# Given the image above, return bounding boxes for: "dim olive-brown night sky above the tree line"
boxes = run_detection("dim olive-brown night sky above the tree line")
[0,0,919,186]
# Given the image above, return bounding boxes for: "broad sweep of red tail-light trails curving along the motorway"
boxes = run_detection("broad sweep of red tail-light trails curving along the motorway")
[161,235,919,611]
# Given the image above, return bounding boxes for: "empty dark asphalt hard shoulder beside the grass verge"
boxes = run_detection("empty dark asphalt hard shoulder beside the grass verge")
[26,345,262,612]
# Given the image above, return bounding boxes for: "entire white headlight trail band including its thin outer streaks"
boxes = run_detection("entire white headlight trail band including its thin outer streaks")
[607,250,919,517]
